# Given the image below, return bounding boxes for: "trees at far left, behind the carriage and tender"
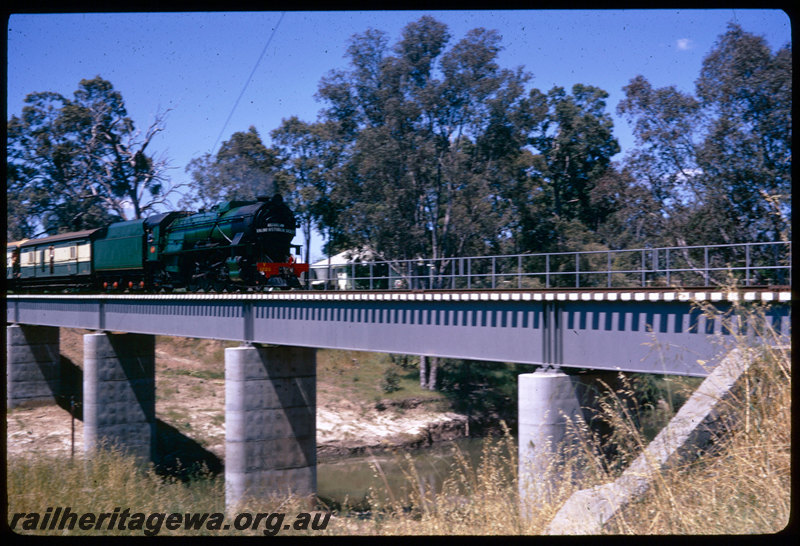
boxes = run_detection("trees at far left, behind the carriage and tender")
[6,76,168,239]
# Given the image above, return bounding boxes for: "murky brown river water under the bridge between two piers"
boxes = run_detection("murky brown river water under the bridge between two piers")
[317,438,516,507]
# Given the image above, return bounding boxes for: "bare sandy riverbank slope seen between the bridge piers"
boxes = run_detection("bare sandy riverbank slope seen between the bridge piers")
[6,328,476,467]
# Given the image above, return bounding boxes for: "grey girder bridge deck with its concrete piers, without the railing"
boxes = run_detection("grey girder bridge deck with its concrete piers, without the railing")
[6,288,791,510]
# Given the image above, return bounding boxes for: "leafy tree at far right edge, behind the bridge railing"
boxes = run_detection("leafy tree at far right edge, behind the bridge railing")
[618,24,792,244]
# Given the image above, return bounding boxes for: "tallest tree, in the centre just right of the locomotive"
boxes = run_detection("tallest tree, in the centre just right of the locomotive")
[310,17,527,259]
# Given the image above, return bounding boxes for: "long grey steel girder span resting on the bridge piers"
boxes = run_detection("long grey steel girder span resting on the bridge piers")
[6,290,791,377]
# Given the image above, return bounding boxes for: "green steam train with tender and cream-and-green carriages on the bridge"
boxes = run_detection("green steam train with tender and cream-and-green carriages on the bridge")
[6,194,308,292]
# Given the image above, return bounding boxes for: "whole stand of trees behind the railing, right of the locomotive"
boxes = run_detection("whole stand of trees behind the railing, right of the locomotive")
[255,16,791,269]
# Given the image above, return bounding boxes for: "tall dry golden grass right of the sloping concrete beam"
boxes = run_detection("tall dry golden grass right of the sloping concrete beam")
[607,298,792,534]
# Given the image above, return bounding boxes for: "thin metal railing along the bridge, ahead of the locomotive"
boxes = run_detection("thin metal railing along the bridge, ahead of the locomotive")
[310,241,792,290]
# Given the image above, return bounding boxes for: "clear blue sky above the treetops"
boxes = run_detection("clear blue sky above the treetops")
[6,9,791,260]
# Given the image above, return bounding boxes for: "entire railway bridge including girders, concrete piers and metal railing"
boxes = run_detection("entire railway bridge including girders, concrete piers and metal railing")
[6,241,792,516]
